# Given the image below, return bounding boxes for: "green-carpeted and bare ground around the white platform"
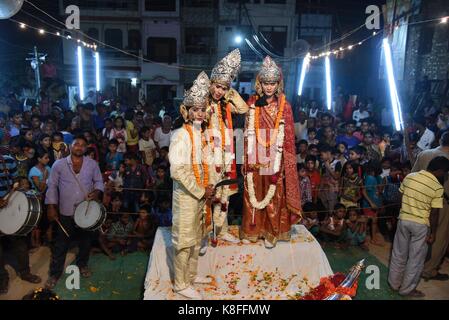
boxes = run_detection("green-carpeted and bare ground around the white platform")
[0,236,449,300]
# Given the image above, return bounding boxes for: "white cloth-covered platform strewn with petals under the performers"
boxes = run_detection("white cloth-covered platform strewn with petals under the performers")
[144,225,333,300]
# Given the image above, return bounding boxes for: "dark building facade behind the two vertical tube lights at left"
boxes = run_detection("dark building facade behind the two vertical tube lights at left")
[59,0,142,102]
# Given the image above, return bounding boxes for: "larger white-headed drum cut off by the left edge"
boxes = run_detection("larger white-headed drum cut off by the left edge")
[0,191,42,236]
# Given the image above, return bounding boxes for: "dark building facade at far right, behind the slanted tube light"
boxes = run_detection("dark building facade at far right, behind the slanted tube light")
[385,0,449,110]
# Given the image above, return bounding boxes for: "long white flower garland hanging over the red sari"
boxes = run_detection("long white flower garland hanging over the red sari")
[246,105,285,210]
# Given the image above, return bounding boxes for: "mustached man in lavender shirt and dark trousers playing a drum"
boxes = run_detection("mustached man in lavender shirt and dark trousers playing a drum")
[45,136,104,289]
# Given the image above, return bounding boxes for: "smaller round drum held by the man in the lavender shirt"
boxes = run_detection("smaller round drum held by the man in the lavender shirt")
[74,200,107,231]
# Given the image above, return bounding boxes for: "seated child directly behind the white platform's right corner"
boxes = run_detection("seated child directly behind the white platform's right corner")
[320,203,346,243]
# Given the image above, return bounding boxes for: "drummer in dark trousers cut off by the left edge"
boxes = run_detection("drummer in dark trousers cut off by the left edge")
[0,154,42,295]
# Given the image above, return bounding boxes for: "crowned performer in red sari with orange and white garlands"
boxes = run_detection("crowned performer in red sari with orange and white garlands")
[240,57,301,248]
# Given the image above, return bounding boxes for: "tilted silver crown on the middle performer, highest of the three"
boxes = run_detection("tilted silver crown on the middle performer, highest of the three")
[210,49,242,87]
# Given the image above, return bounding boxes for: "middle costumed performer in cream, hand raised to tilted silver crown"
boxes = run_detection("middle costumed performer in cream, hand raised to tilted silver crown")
[206,49,249,245]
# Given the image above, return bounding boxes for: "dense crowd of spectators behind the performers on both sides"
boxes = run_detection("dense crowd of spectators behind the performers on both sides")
[0,78,449,284]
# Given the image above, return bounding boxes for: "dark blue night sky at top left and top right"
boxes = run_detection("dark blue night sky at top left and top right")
[0,0,385,96]
